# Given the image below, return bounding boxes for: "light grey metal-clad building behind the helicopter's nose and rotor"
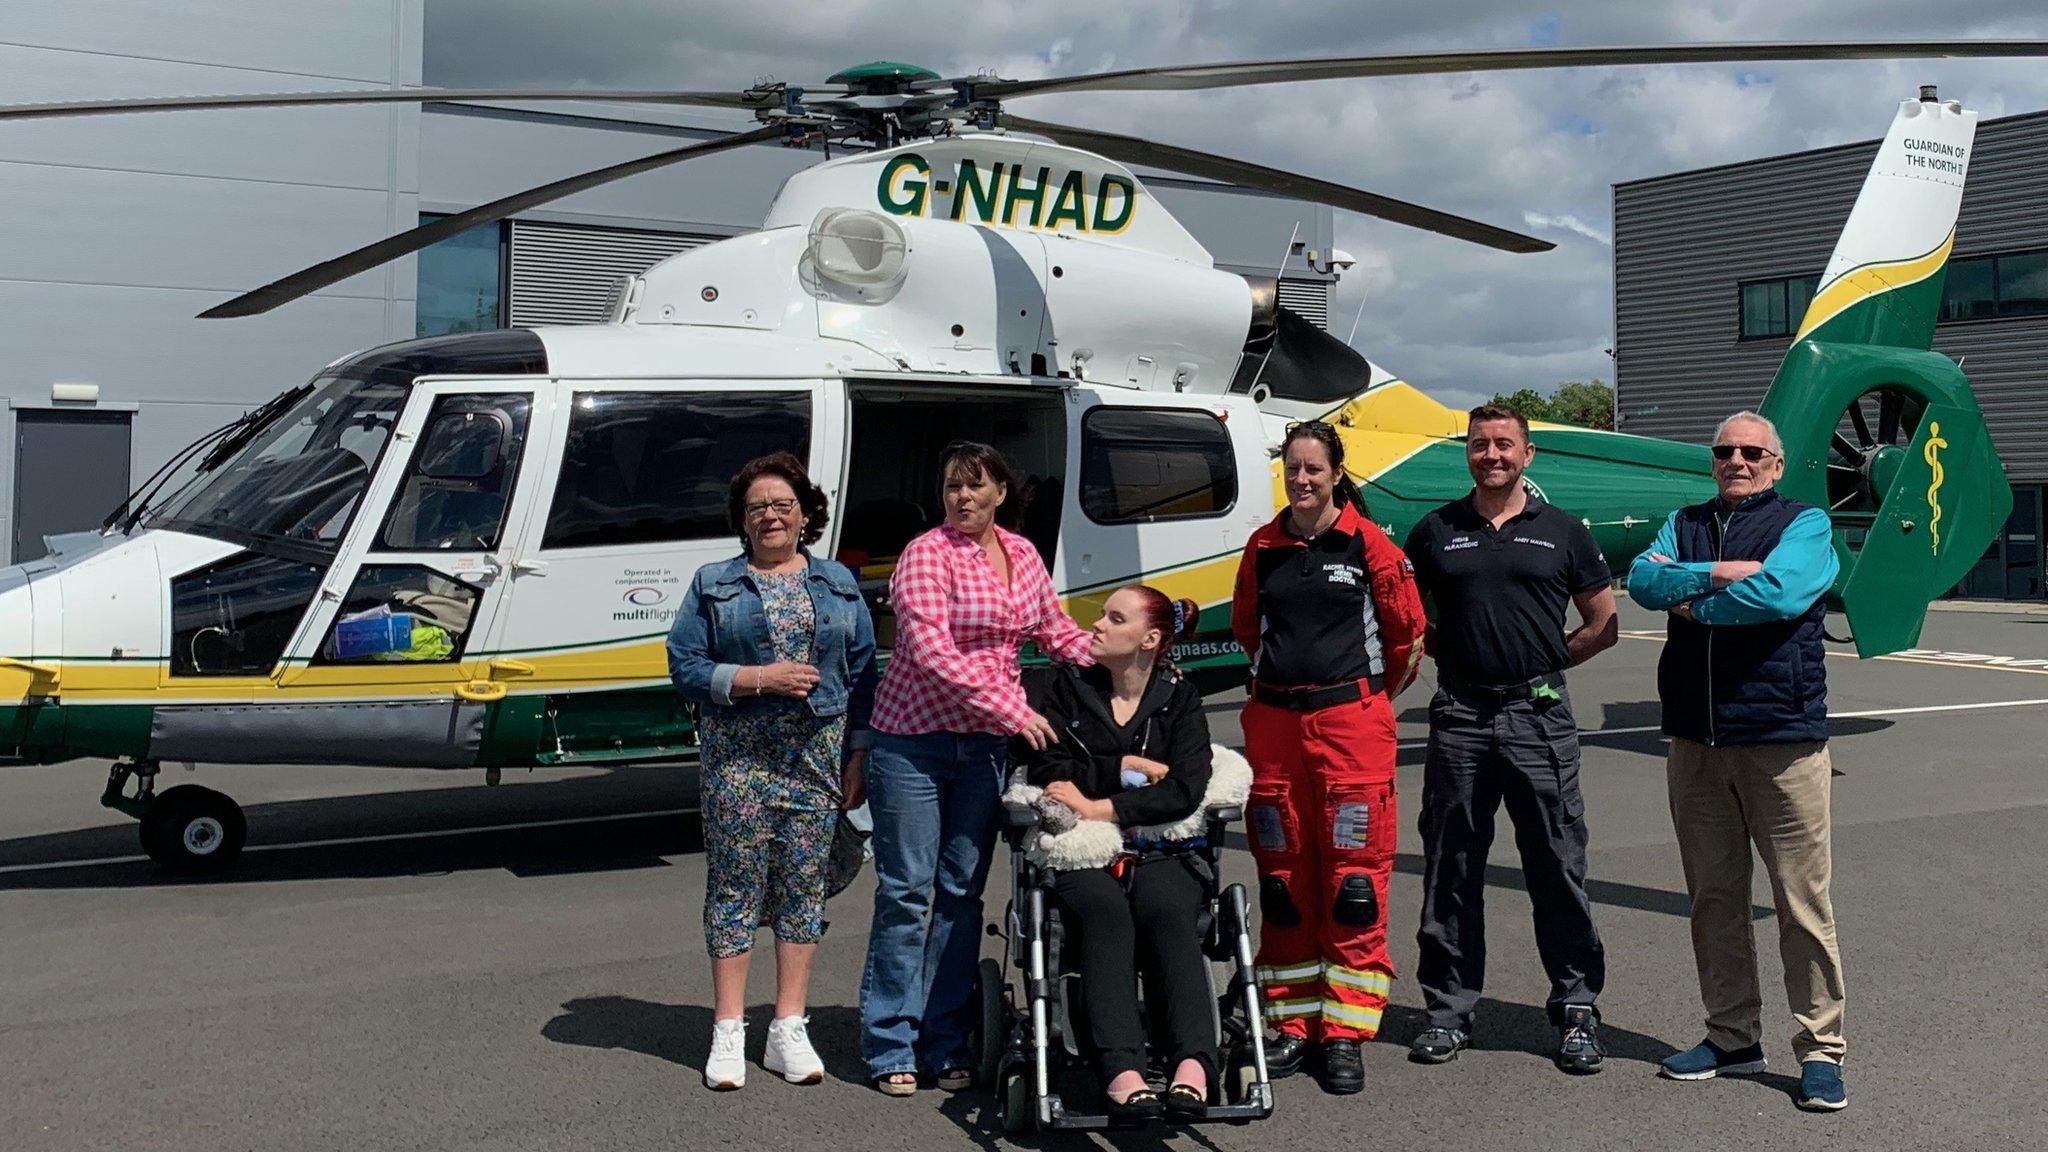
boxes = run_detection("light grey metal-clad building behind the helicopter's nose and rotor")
[0,0,1333,564]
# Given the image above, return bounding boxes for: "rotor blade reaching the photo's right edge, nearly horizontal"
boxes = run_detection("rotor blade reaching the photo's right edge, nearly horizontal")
[973,39,2048,100]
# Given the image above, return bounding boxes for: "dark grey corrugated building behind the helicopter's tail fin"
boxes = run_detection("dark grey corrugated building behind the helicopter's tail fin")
[1614,103,2048,599]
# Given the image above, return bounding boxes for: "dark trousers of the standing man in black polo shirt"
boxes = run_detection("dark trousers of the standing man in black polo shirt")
[1415,691,1608,1031]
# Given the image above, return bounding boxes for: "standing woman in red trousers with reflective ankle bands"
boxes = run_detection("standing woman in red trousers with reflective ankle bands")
[1231,420,1423,1095]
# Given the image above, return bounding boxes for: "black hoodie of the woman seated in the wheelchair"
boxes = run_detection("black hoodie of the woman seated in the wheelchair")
[1010,664,1210,826]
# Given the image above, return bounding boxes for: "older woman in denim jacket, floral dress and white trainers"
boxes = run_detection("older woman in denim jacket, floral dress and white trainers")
[668,453,874,1091]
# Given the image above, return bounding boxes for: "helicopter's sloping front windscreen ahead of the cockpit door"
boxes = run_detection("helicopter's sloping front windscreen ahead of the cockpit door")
[156,379,412,553]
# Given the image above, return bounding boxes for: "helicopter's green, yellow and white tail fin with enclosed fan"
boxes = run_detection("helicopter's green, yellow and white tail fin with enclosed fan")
[1761,100,2013,656]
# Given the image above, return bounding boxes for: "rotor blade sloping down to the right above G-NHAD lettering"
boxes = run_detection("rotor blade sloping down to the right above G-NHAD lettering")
[997,113,1556,252]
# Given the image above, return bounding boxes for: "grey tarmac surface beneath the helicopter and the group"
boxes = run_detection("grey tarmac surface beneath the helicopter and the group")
[0,603,2048,1152]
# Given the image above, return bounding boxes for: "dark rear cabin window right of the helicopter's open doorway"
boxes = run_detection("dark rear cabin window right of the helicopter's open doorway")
[1081,408,1237,525]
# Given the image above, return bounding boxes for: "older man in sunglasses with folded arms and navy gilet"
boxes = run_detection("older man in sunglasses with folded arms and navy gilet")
[1628,412,1849,1111]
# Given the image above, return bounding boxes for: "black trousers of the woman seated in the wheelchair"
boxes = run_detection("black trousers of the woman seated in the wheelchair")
[1053,855,1217,1082]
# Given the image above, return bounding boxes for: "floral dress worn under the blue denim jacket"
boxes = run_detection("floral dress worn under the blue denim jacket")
[700,568,846,957]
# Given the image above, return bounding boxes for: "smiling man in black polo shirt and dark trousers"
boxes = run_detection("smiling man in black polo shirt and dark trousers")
[1407,404,1620,1074]
